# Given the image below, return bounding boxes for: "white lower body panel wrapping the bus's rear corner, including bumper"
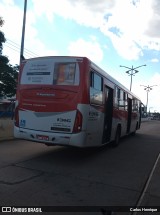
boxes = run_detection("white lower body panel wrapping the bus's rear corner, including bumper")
[14,104,104,147]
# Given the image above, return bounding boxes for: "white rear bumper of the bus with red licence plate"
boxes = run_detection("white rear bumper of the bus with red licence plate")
[14,126,86,147]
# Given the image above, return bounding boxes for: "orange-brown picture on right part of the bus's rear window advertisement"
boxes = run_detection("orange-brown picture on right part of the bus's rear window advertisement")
[53,63,79,85]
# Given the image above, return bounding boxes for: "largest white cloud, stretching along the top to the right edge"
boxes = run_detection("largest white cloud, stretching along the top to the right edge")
[32,0,160,60]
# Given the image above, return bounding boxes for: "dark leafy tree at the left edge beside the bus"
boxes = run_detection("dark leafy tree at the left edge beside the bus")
[0,17,18,97]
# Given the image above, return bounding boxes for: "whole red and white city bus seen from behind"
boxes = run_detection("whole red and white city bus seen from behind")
[14,56,141,147]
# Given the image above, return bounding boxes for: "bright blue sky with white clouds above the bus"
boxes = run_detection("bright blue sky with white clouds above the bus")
[0,0,160,112]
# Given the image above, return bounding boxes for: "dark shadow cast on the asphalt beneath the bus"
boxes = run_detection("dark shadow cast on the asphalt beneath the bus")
[18,128,160,170]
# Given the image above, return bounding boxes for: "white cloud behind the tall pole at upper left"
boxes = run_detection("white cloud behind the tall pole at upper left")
[0,0,58,64]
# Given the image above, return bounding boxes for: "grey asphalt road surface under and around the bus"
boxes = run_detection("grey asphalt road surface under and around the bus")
[0,121,160,215]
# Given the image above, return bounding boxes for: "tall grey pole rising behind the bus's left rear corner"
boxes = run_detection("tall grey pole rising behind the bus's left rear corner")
[19,0,27,65]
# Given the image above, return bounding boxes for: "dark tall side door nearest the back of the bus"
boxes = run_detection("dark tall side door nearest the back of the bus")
[102,86,113,144]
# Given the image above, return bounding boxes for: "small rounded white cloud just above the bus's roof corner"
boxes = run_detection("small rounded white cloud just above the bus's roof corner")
[68,38,103,63]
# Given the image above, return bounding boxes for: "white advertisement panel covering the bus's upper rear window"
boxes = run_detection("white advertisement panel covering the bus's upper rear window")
[20,59,79,85]
